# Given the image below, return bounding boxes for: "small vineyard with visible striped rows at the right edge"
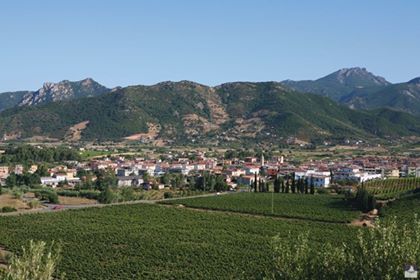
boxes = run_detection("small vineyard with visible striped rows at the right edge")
[363,177,420,200]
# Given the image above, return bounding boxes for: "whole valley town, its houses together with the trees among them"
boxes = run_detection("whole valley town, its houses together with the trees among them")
[0,146,420,211]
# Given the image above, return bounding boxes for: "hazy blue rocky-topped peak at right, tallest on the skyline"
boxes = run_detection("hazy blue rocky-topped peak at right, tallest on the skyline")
[282,67,391,101]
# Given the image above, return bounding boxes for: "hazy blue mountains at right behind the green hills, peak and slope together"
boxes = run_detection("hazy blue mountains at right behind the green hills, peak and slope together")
[283,67,420,116]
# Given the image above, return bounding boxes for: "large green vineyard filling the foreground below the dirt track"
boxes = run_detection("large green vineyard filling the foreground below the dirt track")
[0,204,356,279]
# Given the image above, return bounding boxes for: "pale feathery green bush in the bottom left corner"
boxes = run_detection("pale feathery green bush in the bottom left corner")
[0,240,64,280]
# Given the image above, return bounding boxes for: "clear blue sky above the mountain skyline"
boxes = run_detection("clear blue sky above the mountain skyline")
[0,0,420,92]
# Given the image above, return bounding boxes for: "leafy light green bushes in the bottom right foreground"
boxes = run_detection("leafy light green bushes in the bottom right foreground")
[267,217,420,279]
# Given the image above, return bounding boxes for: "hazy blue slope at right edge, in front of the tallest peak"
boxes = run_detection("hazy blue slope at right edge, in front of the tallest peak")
[340,78,420,116]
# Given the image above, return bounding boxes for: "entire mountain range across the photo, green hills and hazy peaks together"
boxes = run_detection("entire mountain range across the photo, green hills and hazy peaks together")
[0,68,420,144]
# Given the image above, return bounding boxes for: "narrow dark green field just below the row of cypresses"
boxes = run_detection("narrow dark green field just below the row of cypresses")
[164,193,360,223]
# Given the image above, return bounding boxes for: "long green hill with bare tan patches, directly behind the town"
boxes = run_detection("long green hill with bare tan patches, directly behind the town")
[0,81,420,144]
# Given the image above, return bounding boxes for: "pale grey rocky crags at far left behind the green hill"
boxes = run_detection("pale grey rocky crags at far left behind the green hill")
[0,78,110,111]
